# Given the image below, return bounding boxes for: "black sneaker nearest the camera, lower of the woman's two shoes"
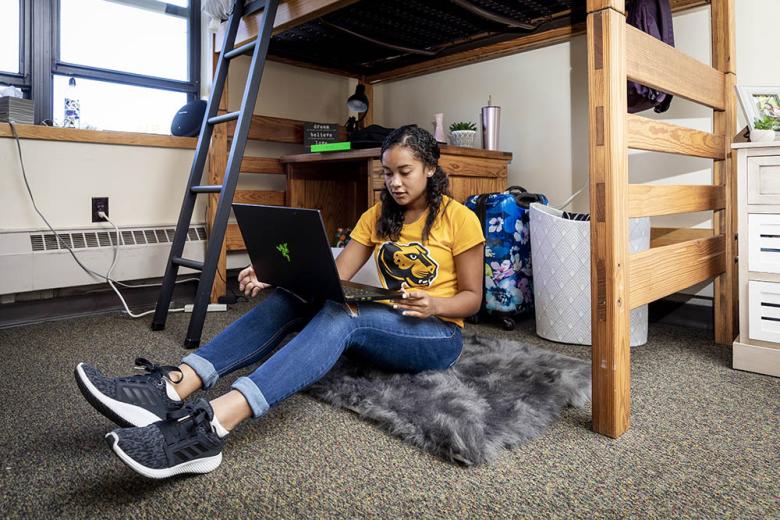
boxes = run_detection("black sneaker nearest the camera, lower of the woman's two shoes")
[106,399,225,478]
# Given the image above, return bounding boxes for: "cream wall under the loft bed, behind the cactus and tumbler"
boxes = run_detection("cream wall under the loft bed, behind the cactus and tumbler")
[374,37,588,212]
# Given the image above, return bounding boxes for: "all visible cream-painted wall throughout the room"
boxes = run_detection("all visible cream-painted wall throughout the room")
[0,0,780,294]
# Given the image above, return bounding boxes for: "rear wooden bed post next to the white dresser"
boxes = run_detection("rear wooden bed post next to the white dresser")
[711,0,739,345]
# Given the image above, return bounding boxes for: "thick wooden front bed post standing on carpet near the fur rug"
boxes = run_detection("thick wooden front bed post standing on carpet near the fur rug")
[587,0,631,438]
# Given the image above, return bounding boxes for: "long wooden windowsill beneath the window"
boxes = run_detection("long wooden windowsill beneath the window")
[0,123,198,150]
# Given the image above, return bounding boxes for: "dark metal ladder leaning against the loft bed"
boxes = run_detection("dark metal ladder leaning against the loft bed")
[152,0,279,348]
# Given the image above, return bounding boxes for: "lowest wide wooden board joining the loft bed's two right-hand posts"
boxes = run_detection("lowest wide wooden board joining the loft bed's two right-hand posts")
[629,235,726,309]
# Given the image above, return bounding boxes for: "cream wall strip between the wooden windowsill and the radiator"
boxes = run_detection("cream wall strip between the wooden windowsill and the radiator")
[0,139,195,231]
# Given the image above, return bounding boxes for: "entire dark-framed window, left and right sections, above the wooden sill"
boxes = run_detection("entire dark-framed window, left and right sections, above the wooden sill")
[8,0,200,134]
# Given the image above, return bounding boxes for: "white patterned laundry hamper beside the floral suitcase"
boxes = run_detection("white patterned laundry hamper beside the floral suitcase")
[529,204,650,347]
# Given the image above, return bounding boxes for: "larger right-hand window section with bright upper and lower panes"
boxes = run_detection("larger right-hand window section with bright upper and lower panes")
[51,0,200,134]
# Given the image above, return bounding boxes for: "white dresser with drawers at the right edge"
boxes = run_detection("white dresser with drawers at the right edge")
[733,141,780,377]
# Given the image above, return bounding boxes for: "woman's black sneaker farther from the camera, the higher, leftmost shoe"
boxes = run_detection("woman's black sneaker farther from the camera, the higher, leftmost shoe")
[74,358,182,426]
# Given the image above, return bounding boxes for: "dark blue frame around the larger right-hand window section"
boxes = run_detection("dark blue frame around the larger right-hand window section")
[27,0,201,124]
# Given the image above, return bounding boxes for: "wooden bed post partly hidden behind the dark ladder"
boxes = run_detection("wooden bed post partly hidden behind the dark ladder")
[206,36,230,303]
